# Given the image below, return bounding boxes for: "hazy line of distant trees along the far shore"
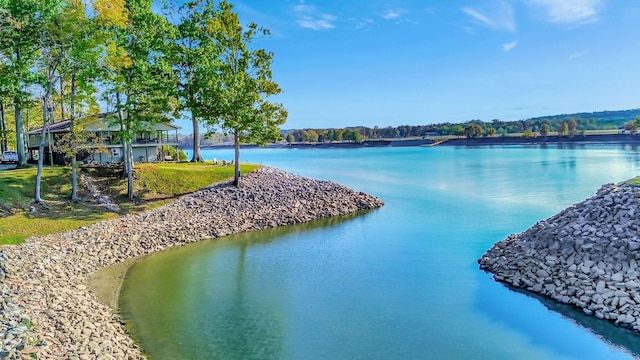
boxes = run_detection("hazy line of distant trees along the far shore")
[282,109,640,143]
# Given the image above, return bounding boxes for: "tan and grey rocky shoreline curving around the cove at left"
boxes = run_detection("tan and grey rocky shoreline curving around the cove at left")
[0,168,383,359]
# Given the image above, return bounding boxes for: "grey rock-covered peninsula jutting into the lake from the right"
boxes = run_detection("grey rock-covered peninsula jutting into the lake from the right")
[478,183,640,332]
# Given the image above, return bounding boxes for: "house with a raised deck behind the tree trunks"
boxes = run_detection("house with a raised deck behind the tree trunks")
[27,115,181,164]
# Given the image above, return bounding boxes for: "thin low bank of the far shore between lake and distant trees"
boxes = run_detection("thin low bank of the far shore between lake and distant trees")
[191,134,640,150]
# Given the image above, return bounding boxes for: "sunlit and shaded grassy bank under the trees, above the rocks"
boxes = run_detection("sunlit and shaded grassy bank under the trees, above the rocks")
[0,163,258,245]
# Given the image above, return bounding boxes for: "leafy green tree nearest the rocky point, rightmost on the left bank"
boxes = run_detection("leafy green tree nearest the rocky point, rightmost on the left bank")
[203,1,287,186]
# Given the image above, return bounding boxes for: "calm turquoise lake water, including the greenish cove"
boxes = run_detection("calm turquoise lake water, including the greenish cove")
[120,145,640,359]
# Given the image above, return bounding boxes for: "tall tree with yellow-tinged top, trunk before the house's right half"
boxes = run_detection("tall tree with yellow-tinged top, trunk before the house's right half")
[94,0,177,199]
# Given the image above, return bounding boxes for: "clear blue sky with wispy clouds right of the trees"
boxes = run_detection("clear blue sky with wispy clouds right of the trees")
[178,0,640,129]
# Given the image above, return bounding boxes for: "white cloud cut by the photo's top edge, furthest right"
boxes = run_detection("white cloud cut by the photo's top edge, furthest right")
[529,0,603,24]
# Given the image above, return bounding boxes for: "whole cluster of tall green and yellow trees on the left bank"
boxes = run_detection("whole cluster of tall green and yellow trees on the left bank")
[0,0,287,202]
